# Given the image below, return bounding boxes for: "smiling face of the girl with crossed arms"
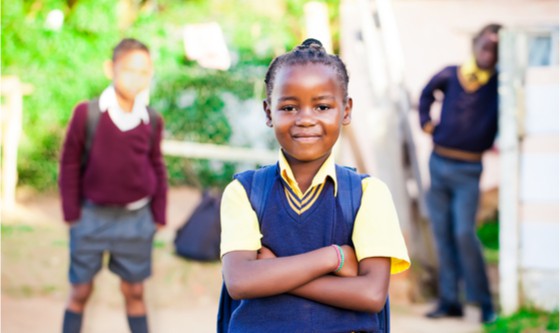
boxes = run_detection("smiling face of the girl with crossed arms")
[264,64,352,163]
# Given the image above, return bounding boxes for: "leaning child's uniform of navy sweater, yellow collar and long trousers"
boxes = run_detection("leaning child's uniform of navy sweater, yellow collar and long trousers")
[419,59,498,314]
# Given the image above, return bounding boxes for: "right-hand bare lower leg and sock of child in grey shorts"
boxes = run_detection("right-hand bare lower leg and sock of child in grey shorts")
[121,280,148,333]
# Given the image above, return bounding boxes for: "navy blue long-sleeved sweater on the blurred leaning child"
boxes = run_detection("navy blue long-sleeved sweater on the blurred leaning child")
[418,66,498,153]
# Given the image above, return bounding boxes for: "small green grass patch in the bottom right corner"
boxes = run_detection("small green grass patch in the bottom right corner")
[484,308,558,333]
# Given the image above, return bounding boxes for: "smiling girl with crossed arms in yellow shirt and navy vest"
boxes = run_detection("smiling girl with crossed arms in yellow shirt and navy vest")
[221,39,410,333]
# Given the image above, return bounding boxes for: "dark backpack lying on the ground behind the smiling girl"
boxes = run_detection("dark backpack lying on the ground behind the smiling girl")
[174,191,222,261]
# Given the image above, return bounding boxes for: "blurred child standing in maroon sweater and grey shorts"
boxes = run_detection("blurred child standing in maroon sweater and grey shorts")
[59,39,167,333]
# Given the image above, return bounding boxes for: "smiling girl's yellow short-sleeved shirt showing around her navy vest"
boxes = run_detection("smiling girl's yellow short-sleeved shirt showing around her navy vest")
[220,152,410,274]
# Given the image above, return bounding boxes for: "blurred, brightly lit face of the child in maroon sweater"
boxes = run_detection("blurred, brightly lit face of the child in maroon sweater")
[111,50,153,101]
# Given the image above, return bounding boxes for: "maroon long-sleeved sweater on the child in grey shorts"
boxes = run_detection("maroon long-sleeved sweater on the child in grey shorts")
[58,102,167,224]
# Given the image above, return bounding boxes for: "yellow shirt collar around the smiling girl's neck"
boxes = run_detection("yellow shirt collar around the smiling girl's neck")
[278,150,338,198]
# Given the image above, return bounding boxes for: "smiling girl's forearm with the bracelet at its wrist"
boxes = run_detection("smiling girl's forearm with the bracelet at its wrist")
[223,246,338,299]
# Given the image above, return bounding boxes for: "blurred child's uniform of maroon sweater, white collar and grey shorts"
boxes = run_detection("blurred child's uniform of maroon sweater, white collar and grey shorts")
[59,86,167,284]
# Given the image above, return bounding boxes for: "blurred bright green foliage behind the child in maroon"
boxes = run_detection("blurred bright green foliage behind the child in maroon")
[1,0,338,190]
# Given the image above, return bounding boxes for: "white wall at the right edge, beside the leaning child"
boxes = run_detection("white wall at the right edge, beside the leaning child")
[519,66,560,310]
